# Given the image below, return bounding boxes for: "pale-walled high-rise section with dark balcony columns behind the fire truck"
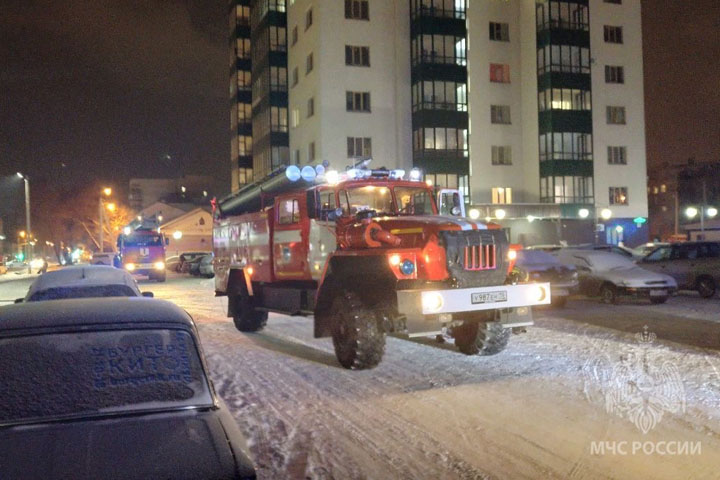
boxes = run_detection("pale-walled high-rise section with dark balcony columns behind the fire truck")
[232,0,647,243]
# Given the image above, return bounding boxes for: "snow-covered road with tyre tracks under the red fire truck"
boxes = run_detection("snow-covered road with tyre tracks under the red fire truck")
[0,277,720,479]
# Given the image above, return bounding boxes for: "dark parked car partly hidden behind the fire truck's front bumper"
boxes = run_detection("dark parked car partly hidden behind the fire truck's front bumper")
[513,250,578,308]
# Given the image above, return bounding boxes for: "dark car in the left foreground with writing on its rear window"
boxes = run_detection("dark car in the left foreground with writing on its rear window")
[0,298,255,479]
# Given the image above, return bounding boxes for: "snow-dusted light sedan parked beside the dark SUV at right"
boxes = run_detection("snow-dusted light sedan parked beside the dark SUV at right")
[556,249,677,304]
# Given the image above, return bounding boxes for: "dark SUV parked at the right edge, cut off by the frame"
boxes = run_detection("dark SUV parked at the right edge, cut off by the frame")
[639,242,720,298]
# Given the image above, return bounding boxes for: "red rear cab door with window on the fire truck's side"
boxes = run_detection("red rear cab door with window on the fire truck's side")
[273,192,310,280]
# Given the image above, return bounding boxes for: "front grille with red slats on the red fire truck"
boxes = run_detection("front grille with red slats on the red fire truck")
[440,230,508,288]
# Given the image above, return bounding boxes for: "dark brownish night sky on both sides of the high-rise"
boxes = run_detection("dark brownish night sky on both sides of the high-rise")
[0,0,720,236]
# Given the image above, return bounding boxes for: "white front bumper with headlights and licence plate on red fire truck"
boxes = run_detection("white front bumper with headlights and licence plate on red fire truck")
[397,283,551,337]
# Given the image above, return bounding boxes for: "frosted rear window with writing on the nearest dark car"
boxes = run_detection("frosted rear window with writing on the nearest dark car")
[0,329,213,425]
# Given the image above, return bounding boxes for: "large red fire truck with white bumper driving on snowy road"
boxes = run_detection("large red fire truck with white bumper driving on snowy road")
[213,166,550,369]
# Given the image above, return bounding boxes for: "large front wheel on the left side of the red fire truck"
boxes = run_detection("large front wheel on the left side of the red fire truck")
[329,290,385,370]
